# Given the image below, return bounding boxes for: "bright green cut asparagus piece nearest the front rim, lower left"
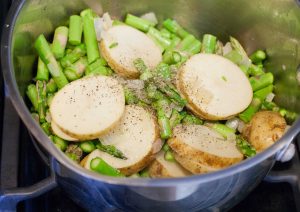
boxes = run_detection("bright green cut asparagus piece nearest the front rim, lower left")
[90,157,124,177]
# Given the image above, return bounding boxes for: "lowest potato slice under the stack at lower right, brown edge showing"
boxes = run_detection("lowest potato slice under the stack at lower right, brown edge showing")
[173,152,221,174]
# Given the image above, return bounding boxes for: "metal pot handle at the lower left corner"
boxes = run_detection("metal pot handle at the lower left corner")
[0,173,57,211]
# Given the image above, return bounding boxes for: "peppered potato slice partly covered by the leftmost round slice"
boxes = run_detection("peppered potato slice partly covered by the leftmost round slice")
[82,105,161,175]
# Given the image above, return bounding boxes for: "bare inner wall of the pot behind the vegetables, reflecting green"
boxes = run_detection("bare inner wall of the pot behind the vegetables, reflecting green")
[11,0,300,112]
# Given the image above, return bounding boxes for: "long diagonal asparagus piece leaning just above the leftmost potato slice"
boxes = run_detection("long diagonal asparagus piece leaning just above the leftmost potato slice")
[35,35,68,88]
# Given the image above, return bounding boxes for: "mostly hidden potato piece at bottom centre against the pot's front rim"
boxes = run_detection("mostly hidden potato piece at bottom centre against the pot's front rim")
[149,151,191,178]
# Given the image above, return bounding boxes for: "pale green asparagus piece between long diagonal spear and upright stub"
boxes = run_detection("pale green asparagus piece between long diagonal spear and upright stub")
[51,26,69,59]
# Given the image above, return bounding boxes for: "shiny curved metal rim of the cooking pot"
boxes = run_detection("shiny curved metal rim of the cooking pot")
[1,0,300,187]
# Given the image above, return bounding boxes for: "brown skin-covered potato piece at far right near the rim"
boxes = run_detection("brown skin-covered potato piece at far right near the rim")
[242,111,287,152]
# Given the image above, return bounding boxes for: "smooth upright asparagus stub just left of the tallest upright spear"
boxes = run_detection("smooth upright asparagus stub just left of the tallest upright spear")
[69,15,83,45]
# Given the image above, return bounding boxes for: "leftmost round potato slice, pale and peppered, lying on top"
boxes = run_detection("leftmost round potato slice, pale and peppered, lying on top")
[50,76,125,140]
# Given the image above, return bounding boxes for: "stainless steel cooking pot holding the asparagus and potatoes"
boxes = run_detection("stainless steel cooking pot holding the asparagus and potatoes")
[0,0,300,211]
